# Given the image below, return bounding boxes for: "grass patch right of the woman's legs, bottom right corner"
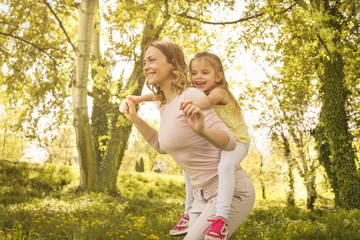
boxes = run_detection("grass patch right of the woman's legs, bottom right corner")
[238,202,360,240]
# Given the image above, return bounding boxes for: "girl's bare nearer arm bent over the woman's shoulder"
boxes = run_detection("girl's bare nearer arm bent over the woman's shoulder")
[180,87,230,110]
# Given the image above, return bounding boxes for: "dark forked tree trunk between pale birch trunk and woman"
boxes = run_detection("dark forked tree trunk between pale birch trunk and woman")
[83,1,169,194]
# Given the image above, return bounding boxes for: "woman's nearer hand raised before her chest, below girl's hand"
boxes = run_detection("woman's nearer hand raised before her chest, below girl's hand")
[183,104,205,135]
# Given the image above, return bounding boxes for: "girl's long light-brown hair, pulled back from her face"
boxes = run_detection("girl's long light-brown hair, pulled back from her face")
[190,52,242,114]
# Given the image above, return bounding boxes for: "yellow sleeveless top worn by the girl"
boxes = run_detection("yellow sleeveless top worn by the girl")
[213,102,251,144]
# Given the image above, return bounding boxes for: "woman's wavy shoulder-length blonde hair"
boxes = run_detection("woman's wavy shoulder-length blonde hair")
[145,40,191,106]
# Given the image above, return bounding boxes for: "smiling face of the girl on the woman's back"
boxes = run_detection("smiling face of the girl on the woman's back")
[191,58,221,92]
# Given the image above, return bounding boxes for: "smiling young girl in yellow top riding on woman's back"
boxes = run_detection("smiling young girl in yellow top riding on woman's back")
[132,52,250,240]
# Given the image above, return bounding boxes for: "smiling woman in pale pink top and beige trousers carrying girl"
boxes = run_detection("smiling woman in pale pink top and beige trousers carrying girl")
[120,41,255,240]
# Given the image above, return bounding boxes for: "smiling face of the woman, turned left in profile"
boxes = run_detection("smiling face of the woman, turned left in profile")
[143,46,173,86]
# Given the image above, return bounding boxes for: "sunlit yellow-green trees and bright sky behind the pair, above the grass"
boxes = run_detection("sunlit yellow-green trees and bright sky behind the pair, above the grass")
[0,0,360,239]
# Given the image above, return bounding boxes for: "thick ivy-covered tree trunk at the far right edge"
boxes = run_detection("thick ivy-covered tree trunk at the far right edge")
[295,0,360,209]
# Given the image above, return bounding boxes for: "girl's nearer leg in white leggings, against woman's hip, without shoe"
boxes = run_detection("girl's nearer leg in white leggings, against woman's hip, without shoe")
[216,142,250,220]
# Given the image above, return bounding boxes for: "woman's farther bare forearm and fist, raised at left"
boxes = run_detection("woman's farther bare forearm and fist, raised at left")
[120,97,157,142]
